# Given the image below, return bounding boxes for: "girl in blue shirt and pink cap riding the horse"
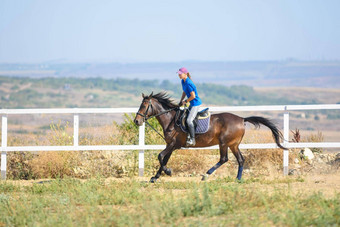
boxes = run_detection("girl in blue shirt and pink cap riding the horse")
[177,67,202,146]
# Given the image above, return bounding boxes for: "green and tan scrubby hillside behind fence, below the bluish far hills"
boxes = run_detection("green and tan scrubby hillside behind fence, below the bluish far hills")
[0,76,340,131]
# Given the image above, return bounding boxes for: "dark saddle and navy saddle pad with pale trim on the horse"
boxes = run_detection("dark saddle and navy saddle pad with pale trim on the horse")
[176,108,210,134]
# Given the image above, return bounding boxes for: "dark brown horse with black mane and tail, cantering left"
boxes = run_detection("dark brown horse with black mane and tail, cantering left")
[134,93,285,182]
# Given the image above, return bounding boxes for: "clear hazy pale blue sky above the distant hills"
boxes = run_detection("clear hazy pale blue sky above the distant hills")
[0,0,340,63]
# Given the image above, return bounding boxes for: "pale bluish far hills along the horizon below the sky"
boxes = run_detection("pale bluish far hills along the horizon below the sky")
[0,60,340,88]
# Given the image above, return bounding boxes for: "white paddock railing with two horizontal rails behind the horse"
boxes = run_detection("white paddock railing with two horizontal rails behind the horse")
[0,104,340,179]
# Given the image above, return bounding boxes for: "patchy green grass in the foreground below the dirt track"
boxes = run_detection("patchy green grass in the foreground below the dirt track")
[0,178,340,226]
